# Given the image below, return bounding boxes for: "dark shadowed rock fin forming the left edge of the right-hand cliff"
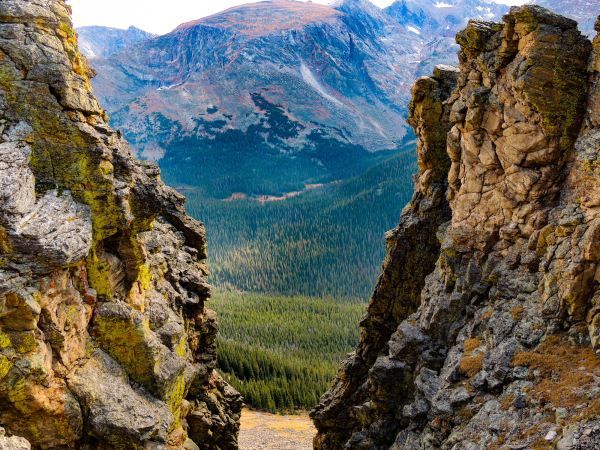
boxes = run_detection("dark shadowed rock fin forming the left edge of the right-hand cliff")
[313,61,458,448]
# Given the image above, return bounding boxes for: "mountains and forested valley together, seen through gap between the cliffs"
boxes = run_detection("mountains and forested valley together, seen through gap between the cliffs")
[78,0,593,416]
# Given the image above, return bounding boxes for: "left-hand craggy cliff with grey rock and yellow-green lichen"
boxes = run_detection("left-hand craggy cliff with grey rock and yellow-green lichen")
[0,0,241,449]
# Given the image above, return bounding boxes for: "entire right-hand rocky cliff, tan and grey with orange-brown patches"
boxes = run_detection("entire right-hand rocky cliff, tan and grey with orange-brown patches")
[312,6,600,449]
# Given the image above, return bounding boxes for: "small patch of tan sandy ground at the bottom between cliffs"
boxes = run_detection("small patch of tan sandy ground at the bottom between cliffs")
[239,409,316,450]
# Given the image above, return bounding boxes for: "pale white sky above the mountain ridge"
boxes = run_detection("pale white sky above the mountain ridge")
[67,0,525,34]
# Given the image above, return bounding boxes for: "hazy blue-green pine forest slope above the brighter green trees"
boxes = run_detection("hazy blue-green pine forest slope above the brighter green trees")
[172,151,416,300]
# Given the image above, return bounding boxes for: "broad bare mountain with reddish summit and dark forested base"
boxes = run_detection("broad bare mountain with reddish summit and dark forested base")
[82,0,421,197]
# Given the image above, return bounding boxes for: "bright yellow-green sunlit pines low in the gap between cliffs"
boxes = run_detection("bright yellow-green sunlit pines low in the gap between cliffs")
[211,291,365,412]
